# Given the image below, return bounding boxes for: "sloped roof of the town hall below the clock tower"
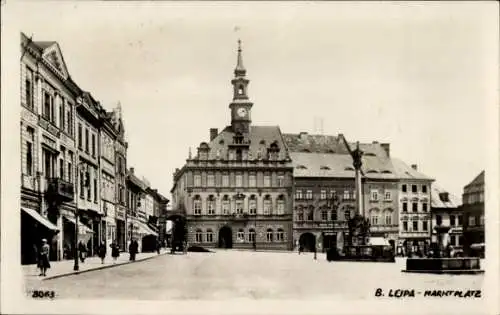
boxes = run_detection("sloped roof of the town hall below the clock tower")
[202,126,288,160]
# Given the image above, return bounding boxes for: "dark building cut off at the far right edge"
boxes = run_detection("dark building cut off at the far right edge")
[461,171,485,255]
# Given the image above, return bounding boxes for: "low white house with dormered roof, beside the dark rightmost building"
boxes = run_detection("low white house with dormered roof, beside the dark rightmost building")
[431,184,463,250]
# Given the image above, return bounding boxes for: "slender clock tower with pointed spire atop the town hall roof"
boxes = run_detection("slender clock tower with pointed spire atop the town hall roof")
[229,40,253,133]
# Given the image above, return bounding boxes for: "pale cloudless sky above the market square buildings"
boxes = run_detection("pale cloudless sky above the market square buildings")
[13,1,498,198]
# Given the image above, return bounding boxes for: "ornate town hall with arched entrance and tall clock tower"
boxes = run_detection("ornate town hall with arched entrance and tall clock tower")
[171,42,293,250]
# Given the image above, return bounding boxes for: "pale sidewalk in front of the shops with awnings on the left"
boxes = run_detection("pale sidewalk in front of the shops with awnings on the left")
[22,248,170,281]
